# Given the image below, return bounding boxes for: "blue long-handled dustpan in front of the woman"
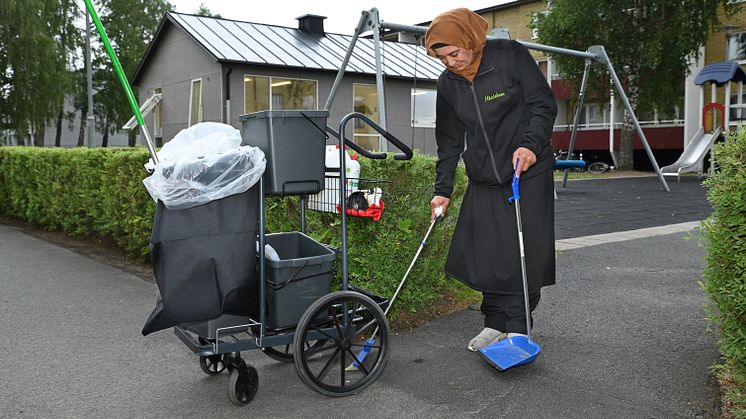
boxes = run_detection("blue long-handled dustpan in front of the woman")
[479,161,541,371]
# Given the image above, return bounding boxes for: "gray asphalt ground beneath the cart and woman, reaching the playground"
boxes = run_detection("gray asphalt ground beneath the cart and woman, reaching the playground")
[0,177,718,418]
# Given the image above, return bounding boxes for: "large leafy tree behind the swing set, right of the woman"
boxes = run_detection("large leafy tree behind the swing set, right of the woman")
[535,0,727,169]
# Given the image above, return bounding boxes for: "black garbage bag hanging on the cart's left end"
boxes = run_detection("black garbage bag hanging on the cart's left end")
[142,189,259,335]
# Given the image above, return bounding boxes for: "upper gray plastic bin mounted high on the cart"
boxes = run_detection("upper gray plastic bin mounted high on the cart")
[239,111,329,196]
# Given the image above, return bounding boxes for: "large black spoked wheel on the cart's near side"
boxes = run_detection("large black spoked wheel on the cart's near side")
[293,291,389,397]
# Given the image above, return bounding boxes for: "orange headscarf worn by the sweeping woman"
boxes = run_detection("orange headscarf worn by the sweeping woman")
[425,7,488,81]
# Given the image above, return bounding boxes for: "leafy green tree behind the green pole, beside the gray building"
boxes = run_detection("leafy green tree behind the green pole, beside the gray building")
[94,0,173,147]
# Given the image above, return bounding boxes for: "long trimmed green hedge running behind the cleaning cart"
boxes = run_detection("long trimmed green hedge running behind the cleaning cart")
[0,147,466,311]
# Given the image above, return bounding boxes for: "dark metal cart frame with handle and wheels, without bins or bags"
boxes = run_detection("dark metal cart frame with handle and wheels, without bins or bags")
[174,112,413,405]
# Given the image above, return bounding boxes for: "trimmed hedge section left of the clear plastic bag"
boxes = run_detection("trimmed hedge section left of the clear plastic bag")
[0,147,154,259]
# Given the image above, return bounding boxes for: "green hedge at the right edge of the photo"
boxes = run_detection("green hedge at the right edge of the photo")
[703,129,746,417]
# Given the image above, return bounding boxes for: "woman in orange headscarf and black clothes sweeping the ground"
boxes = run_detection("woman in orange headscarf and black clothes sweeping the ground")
[425,8,557,351]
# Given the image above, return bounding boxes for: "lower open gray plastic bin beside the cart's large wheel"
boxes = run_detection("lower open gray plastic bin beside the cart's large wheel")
[264,231,337,329]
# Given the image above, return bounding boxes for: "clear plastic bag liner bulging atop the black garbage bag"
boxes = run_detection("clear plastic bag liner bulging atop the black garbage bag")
[143,122,267,209]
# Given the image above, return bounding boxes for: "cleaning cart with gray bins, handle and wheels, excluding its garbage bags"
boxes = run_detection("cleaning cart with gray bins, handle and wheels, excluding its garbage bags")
[169,111,412,405]
